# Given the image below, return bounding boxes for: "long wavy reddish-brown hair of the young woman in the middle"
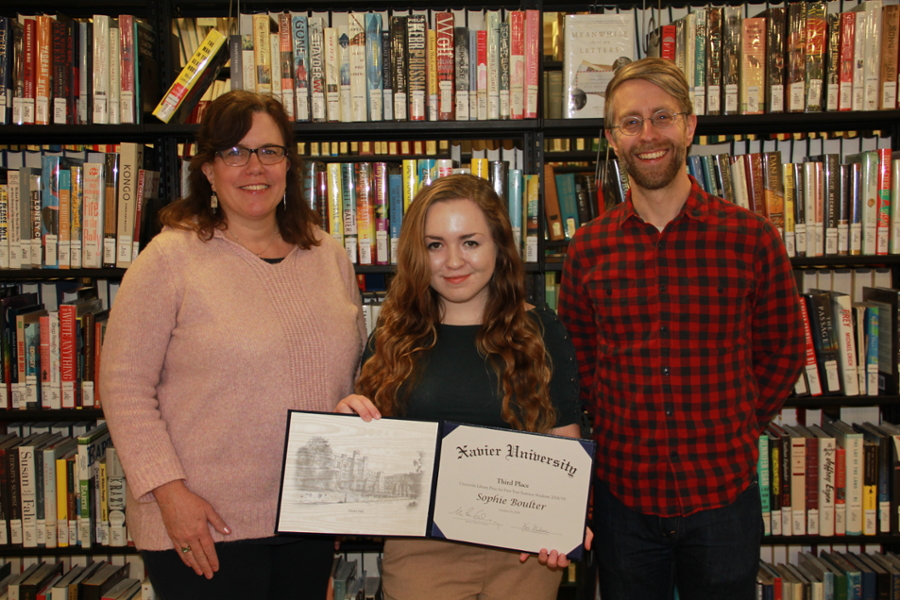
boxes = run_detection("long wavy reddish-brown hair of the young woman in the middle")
[356,175,556,432]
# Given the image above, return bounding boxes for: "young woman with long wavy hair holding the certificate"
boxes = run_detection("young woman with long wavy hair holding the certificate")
[336,175,580,600]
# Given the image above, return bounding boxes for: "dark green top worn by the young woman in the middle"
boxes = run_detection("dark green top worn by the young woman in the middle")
[363,308,581,429]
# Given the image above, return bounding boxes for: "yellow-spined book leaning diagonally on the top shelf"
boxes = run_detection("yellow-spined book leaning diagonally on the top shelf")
[153,29,228,123]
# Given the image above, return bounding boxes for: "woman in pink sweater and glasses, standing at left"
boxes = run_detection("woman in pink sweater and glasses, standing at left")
[100,92,365,600]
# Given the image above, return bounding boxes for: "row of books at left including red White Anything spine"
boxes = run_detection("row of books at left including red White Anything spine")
[0,288,109,410]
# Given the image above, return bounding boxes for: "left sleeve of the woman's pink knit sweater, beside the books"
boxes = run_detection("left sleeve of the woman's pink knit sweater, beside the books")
[100,234,186,502]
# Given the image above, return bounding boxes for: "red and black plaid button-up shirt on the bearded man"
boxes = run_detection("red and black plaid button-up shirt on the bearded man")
[559,181,804,517]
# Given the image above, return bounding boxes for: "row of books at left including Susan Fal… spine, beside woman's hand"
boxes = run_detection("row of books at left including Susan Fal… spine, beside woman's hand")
[0,423,124,549]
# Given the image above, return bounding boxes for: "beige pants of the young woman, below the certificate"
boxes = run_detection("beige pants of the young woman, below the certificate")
[382,539,562,600]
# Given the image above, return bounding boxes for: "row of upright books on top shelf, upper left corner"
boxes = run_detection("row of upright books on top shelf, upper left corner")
[0,14,160,125]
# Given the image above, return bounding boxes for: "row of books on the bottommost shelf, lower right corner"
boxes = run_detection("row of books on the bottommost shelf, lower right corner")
[756,550,900,600]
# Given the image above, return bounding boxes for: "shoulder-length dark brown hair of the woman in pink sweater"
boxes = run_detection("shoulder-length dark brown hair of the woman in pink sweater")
[159,90,319,250]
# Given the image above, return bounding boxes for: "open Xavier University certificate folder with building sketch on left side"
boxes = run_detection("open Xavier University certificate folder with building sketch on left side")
[276,411,595,559]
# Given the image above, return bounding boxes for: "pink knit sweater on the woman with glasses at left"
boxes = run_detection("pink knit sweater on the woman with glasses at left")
[100,230,366,550]
